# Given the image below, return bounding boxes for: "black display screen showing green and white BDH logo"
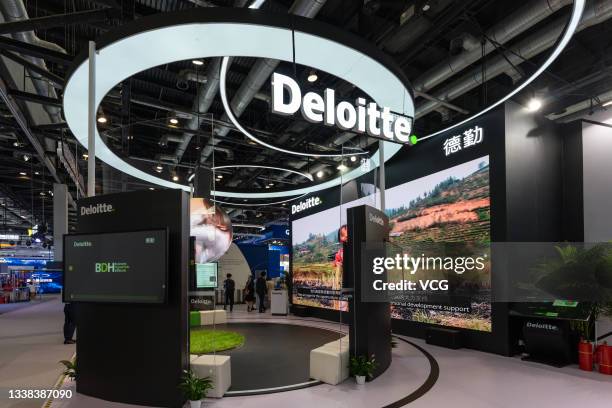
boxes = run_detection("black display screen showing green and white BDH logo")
[64,229,168,303]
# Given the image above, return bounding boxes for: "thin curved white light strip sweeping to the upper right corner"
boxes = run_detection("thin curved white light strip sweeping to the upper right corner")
[419,0,586,141]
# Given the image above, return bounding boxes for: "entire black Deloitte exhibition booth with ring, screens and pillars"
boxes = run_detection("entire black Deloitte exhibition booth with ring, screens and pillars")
[52,3,612,407]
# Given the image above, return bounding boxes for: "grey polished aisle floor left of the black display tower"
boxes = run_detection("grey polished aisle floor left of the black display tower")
[0,295,75,408]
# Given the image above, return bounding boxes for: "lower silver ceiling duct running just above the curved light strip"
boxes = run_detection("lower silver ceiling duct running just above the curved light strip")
[415,0,612,118]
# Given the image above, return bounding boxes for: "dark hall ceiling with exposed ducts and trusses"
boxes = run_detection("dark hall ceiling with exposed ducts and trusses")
[0,0,612,233]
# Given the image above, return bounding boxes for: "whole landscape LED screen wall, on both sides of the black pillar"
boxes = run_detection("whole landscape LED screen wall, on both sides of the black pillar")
[292,156,491,331]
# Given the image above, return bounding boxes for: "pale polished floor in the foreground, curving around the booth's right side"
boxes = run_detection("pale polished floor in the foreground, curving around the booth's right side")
[40,304,612,408]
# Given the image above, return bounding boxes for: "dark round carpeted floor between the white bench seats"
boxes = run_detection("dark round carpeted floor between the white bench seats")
[212,323,342,391]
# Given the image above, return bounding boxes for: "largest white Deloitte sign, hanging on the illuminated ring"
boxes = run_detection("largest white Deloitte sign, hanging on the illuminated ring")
[272,72,412,143]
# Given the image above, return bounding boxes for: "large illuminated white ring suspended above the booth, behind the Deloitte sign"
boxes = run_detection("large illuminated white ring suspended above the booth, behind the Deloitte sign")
[64,7,414,199]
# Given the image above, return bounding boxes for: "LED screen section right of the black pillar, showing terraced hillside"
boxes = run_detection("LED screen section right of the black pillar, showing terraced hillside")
[385,156,491,331]
